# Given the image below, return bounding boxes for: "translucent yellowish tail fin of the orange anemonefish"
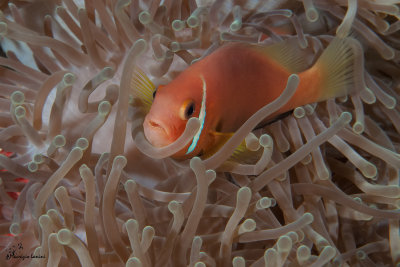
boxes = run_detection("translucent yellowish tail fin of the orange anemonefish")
[312,37,364,101]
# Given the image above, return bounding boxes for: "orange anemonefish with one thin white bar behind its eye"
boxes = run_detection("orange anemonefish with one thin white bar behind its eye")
[136,38,355,159]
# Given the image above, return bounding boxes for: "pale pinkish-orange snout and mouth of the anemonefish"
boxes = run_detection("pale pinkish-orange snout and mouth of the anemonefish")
[143,116,172,147]
